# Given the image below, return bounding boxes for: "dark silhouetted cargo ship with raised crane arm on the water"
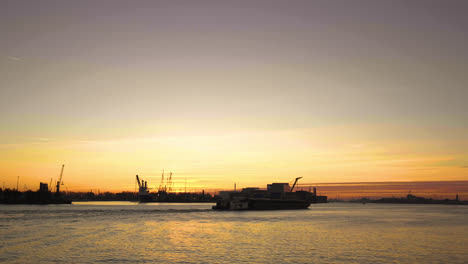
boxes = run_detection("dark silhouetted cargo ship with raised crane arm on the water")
[213,177,327,210]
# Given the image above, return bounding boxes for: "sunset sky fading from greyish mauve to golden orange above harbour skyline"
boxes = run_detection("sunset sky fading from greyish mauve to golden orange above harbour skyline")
[0,0,468,193]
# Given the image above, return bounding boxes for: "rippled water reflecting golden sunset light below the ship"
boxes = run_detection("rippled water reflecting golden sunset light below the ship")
[0,202,468,263]
